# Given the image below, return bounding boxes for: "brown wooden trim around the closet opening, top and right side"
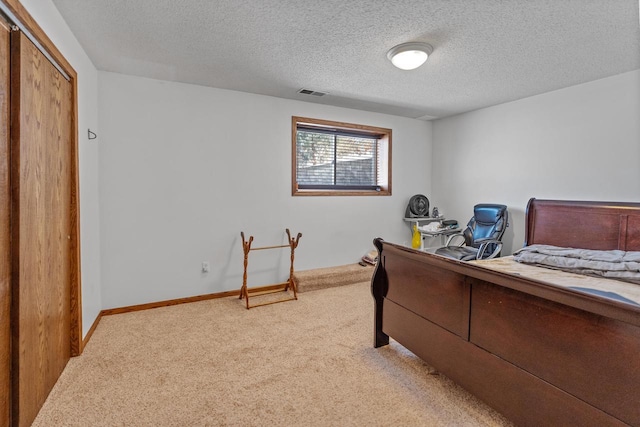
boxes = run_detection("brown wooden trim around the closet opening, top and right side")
[0,0,84,357]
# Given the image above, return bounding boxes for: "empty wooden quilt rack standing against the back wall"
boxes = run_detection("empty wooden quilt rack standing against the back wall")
[240,228,302,310]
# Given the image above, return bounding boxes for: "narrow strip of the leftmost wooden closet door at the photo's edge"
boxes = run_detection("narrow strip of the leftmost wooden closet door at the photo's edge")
[0,15,11,427]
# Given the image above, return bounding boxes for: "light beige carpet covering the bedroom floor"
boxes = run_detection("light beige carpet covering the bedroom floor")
[33,282,510,427]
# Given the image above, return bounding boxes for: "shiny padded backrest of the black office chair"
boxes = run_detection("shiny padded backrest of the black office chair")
[463,203,508,248]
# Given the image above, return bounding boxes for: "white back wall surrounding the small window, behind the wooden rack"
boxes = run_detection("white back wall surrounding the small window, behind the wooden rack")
[98,72,431,308]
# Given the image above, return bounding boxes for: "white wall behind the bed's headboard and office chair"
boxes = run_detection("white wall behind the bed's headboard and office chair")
[432,70,640,253]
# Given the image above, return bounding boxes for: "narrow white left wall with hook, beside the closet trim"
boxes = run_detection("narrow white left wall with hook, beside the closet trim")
[21,0,102,342]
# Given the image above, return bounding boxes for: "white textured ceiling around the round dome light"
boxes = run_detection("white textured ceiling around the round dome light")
[53,0,640,119]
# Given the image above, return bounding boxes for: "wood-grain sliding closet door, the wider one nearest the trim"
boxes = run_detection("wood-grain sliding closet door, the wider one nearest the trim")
[11,32,72,426]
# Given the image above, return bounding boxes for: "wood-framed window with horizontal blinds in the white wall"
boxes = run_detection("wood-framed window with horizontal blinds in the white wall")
[291,116,391,196]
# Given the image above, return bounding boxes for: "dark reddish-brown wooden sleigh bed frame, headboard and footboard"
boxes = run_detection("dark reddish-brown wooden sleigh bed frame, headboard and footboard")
[371,199,640,426]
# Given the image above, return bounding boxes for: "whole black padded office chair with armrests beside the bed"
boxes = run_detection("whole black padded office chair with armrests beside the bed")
[435,204,509,261]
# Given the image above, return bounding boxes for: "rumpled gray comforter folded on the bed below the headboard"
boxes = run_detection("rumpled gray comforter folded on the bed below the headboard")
[513,245,640,284]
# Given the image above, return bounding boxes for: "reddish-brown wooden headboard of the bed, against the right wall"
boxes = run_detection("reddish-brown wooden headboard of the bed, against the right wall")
[524,198,640,251]
